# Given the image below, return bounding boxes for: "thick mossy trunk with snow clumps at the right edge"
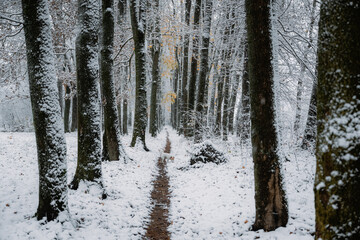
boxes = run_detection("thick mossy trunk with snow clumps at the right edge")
[314,0,360,239]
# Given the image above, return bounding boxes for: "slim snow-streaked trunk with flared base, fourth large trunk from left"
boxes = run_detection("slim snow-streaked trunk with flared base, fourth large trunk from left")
[130,0,149,151]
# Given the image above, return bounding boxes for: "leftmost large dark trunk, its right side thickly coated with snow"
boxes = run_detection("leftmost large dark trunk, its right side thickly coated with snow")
[22,0,68,221]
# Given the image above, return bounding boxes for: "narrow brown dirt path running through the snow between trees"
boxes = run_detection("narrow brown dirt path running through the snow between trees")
[145,133,171,240]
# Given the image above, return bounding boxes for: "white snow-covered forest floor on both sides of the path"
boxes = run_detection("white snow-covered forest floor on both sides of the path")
[0,127,315,240]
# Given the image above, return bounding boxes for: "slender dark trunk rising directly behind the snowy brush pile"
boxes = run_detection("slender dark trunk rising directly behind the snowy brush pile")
[195,0,213,142]
